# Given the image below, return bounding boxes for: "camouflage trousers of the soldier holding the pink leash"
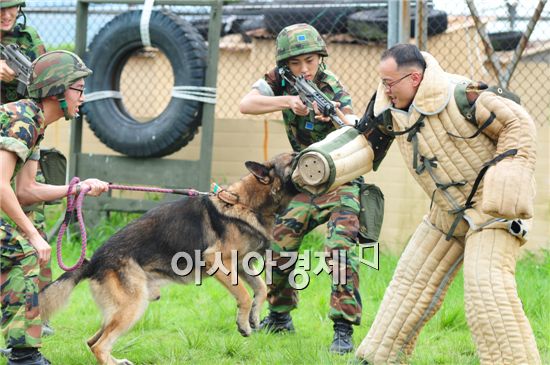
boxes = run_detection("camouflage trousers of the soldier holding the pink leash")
[0,219,42,348]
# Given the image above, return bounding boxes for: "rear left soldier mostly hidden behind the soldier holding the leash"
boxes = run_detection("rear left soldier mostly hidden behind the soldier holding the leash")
[0,0,53,336]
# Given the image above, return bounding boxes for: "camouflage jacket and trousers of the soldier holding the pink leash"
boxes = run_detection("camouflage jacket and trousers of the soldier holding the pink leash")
[0,99,45,348]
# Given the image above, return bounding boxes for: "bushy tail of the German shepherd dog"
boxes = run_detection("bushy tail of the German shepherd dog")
[38,259,91,321]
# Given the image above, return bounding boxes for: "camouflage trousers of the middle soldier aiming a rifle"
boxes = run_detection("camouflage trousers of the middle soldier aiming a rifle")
[267,184,361,324]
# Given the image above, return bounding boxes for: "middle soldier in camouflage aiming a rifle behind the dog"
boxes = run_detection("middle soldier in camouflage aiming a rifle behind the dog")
[240,24,361,353]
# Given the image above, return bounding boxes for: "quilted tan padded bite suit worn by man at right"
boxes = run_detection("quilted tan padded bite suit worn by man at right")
[356,51,540,364]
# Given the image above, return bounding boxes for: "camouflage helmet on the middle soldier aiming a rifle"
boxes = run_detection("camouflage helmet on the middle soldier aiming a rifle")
[276,23,328,65]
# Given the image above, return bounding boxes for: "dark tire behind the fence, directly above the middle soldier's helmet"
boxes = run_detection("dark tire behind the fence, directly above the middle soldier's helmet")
[265,5,364,34]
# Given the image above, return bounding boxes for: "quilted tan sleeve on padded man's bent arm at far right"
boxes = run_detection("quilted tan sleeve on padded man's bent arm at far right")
[476,92,537,219]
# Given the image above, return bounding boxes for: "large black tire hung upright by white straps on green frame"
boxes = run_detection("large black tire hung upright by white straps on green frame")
[83,11,207,157]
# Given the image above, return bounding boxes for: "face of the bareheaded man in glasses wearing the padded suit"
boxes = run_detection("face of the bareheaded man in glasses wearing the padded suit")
[378,57,421,110]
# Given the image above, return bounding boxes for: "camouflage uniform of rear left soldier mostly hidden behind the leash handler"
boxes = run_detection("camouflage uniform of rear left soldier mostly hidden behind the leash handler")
[0,24,52,289]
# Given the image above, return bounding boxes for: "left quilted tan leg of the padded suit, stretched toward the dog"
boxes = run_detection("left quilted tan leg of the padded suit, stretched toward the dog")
[356,218,464,364]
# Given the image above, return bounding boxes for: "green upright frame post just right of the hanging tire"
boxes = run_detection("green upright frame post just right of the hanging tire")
[199,0,223,190]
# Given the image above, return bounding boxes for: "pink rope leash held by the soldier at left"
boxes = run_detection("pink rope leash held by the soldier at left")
[57,177,210,271]
